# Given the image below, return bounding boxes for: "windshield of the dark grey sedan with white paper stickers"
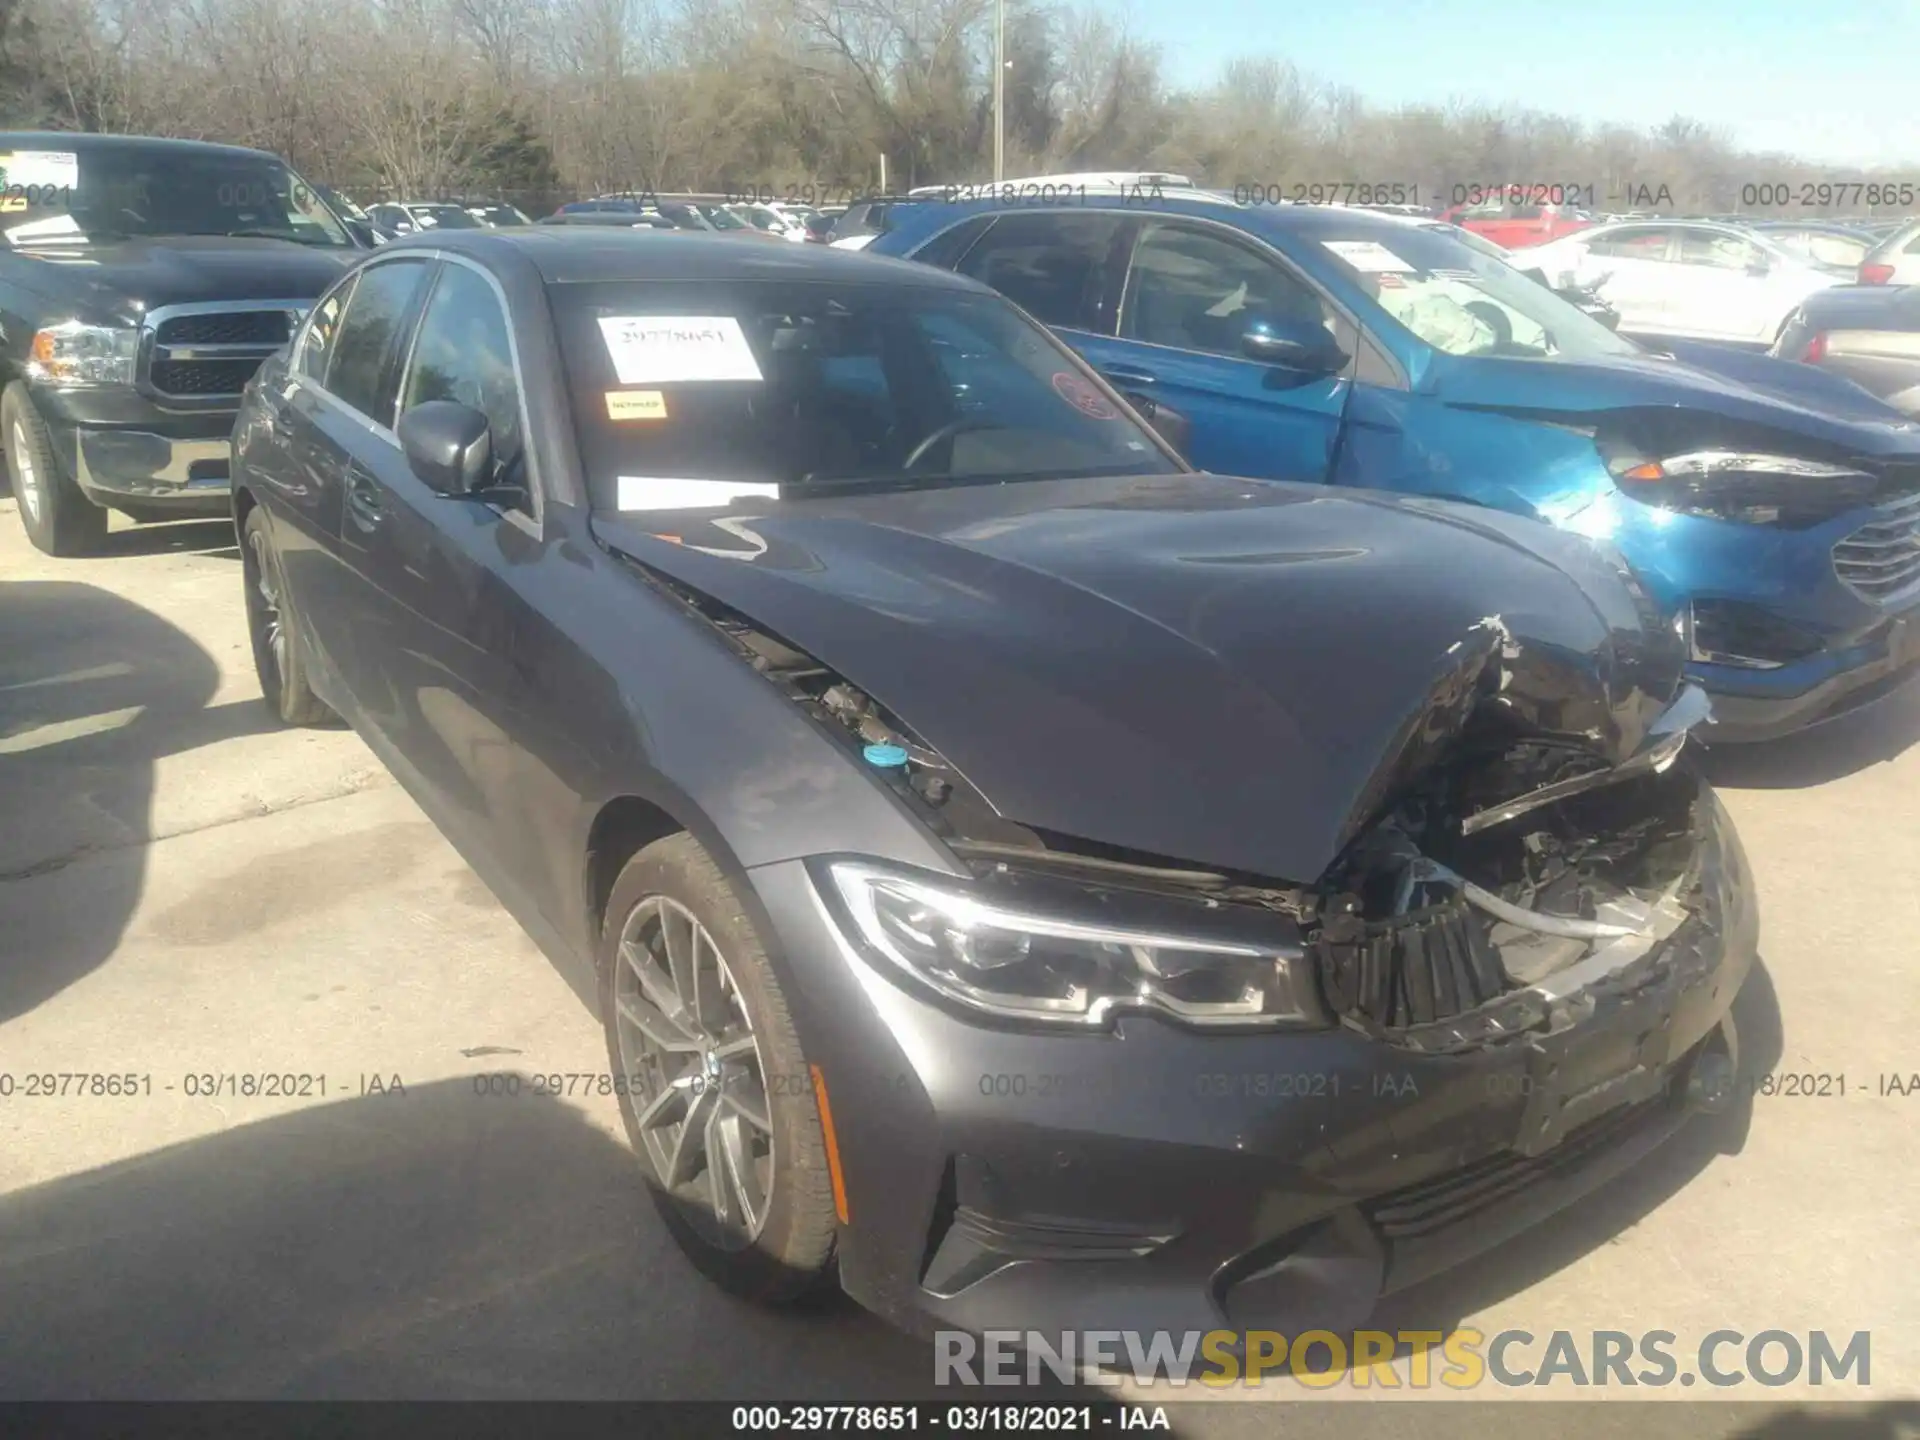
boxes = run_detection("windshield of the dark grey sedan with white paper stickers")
[549,280,1181,511]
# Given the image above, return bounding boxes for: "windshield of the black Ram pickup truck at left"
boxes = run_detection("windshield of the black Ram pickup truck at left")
[0,144,353,250]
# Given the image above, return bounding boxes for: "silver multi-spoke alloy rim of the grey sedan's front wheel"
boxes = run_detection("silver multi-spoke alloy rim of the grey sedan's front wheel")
[612,895,774,1252]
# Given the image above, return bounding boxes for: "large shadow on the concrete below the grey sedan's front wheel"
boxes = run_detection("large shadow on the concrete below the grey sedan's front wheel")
[0,1075,1068,1404]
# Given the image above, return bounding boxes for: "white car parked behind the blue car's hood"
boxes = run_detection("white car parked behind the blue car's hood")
[1526,221,1849,346]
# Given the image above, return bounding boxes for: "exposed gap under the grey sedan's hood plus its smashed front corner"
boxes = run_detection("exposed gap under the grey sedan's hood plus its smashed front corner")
[629,556,1738,1082]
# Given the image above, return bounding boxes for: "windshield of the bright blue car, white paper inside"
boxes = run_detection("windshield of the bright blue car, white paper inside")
[1315,227,1642,359]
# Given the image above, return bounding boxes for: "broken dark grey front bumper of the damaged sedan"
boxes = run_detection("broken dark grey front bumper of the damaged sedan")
[751,801,1759,1332]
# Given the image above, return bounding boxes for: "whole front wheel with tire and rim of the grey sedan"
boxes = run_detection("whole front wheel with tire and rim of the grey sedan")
[597,835,839,1306]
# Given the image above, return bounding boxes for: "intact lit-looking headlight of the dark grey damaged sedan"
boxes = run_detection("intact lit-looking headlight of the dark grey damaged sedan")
[828,862,1325,1029]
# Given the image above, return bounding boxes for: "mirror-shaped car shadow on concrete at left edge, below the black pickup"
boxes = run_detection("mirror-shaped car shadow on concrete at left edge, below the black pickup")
[0,580,273,1023]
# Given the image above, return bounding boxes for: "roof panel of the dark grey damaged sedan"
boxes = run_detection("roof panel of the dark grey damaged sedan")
[380,225,985,292]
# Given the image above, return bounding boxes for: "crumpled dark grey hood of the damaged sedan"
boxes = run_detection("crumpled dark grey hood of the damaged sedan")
[593,474,1682,883]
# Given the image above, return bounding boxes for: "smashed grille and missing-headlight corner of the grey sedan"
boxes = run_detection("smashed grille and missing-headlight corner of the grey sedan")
[1311,706,1716,1054]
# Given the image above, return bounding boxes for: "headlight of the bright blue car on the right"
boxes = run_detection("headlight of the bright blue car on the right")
[1607,449,1880,528]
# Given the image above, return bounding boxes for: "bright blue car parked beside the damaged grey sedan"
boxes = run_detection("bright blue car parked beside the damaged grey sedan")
[872,190,1920,739]
